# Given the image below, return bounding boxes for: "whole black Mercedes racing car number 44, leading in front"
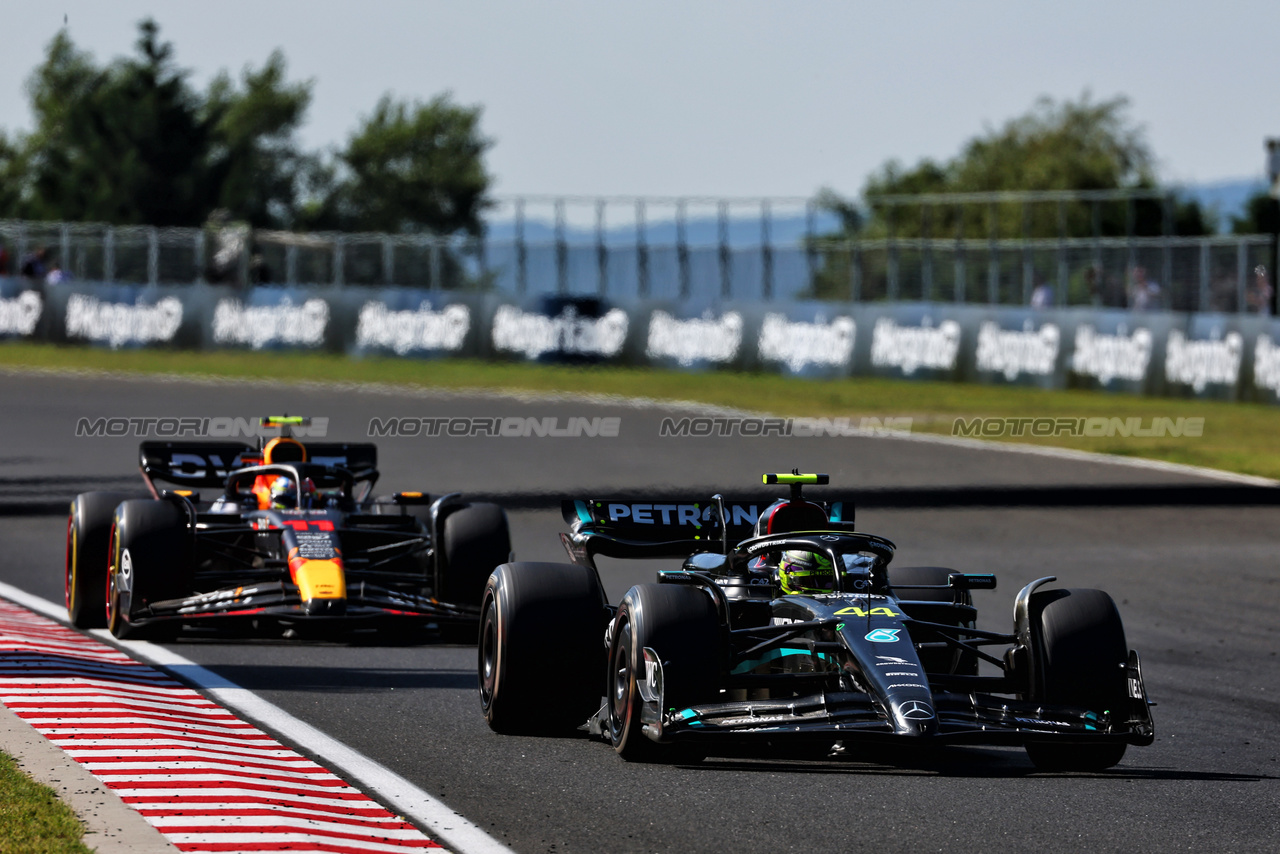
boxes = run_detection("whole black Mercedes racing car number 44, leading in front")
[479,474,1155,769]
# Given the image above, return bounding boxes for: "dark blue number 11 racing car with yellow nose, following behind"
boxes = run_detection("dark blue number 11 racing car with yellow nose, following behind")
[65,416,512,639]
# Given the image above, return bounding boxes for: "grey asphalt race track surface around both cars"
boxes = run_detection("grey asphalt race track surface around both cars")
[0,374,1280,853]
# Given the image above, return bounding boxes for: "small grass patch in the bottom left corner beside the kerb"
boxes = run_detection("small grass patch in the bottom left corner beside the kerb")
[0,753,90,854]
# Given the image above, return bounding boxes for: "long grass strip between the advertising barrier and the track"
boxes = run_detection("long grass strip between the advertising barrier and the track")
[0,342,1280,479]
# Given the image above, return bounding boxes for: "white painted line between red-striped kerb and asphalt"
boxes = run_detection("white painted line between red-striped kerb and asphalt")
[0,581,511,854]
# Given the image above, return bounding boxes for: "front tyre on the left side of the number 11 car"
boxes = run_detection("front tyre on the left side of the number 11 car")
[106,499,192,639]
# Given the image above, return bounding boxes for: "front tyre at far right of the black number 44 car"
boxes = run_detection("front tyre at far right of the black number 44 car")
[1027,589,1129,771]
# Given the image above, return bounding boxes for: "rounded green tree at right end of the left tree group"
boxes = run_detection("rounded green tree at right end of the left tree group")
[310,95,492,234]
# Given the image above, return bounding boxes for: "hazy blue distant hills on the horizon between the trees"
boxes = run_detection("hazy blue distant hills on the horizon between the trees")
[488,178,1267,247]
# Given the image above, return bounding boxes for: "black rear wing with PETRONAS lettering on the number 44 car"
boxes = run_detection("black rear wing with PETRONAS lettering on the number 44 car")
[561,495,850,562]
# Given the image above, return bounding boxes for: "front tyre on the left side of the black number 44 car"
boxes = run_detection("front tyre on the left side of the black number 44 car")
[605,584,721,762]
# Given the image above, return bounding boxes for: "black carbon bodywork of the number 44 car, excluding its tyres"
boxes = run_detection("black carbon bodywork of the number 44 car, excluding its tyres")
[561,492,1155,758]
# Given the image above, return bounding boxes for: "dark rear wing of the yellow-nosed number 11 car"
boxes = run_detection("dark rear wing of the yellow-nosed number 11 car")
[138,442,378,489]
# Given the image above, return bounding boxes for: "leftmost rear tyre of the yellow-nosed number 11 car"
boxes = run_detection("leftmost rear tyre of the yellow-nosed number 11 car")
[65,492,136,629]
